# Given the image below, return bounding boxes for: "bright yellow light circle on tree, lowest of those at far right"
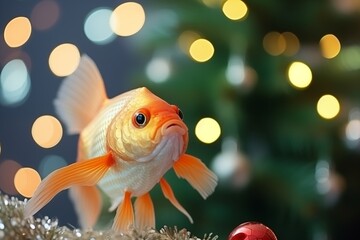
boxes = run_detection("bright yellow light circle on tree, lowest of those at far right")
[317,94,340,119]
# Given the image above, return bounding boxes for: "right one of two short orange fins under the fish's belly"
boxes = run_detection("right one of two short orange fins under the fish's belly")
[135,193,155,229]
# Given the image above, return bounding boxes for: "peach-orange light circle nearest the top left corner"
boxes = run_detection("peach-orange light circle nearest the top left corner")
[4,17,31,48]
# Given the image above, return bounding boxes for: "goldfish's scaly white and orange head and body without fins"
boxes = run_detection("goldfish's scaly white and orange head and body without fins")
[79,88,187,210]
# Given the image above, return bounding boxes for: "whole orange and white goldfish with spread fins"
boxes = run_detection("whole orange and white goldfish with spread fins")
[24,55,217,231]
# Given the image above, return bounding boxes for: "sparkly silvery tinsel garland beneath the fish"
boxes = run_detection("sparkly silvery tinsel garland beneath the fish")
[0,192,218,240]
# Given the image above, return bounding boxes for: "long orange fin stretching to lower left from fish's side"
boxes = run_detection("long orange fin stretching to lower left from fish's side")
[24,153,115,218]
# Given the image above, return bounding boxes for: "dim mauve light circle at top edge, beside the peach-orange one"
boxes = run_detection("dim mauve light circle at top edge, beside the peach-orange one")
[30,0,60,31]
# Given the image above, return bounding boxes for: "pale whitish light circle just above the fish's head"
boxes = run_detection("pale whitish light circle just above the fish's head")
[146,57,171,83]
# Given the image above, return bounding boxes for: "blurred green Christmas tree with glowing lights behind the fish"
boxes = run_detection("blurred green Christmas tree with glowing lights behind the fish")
[121,0,360,240]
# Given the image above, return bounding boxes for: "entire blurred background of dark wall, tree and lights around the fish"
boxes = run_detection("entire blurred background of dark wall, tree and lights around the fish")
[0,0,360,240]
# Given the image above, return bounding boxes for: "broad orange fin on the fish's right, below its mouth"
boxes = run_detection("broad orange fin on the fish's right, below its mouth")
[173,154,218,199]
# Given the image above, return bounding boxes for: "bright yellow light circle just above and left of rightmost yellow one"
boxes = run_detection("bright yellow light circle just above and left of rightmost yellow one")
[288,62,312,88]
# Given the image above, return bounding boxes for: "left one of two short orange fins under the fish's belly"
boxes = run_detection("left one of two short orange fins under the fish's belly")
[112,192,134,232]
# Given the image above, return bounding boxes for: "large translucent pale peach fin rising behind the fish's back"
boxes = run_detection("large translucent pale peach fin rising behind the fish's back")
[54,55,107,134]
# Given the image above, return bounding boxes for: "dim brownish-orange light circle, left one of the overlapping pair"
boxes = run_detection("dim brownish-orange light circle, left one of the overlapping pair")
[263,32,286,56]
